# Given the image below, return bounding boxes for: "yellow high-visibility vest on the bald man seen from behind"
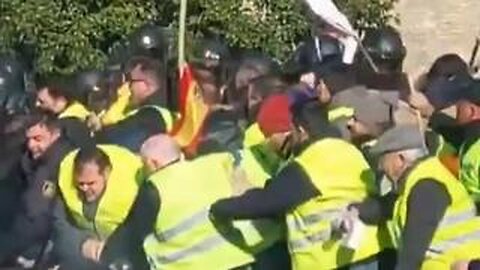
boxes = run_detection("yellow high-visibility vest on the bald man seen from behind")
[144,153,282,270]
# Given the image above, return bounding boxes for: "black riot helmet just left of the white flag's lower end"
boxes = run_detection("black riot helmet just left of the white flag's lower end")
[284,36,343,75]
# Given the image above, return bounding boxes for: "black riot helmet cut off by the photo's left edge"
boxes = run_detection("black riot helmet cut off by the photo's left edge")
[0,54,29,114]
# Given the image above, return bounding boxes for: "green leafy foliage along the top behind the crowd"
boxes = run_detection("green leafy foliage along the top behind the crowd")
[0,0,396,72]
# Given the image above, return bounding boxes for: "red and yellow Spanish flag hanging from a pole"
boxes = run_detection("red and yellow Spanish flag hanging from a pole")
[171,64,210,155]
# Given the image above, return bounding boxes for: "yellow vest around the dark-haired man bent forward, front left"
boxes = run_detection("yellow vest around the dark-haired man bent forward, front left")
[59,145,143,239]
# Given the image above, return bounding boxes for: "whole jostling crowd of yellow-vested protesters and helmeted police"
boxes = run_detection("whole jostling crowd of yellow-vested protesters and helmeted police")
[0,2,480,270]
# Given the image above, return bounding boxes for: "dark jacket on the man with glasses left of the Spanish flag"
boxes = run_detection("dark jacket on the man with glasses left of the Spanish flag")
[96,93,167,152]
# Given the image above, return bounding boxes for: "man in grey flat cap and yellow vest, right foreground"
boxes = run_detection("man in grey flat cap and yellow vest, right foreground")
[352,125,480,270]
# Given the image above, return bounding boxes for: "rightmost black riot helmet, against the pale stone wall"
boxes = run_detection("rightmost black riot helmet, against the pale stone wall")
[362,26,407,73]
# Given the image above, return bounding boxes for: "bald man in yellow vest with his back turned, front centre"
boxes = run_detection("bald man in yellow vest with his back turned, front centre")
[102,135,284,270]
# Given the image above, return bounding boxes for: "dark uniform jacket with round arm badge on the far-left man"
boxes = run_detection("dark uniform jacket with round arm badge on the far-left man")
[0,139,72,262]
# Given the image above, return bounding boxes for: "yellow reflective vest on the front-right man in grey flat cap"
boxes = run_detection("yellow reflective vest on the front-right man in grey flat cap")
[390,157,480,270]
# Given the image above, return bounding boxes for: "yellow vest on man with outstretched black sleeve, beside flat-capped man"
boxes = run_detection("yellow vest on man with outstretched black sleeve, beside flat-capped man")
[287,139,390,270]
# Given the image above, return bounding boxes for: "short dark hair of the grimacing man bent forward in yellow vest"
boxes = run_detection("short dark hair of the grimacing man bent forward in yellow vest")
[73,146,112,174]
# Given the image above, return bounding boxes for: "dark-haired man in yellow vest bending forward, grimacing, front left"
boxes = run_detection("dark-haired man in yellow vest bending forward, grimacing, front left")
[54,145,143,269]
